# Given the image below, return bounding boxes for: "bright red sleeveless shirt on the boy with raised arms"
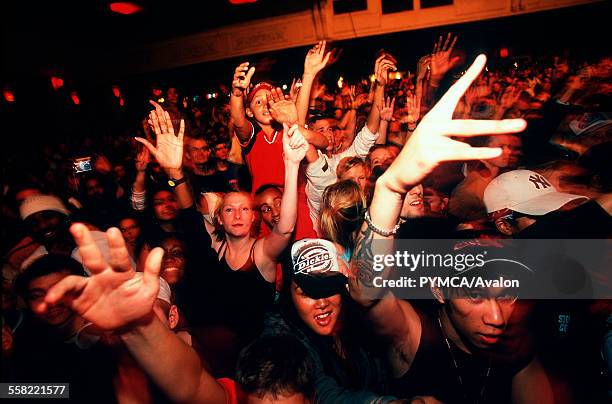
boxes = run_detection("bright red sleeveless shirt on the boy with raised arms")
[241,123,317,240]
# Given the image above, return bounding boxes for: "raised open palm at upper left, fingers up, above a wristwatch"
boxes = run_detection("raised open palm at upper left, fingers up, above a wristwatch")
[136,101,185,170]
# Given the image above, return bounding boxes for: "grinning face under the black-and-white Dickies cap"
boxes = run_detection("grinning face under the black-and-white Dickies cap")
[291,282,342,336]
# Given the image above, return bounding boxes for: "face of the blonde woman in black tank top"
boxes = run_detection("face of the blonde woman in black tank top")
[219,192,255,237]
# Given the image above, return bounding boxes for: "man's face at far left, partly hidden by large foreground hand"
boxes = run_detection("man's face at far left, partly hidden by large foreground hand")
[26,271,74,327]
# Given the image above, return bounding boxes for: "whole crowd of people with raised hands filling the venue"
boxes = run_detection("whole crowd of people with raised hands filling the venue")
[2,34,612,403]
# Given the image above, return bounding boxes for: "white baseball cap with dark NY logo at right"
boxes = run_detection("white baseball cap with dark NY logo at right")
[484,170,588,216]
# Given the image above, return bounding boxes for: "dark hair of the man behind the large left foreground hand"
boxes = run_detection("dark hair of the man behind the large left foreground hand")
[15,254,85,300]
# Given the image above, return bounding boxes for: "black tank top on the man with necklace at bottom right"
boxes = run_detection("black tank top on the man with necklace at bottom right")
[391,311,522,404]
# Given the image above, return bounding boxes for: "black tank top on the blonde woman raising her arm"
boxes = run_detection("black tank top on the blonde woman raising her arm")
[212,241,274,338]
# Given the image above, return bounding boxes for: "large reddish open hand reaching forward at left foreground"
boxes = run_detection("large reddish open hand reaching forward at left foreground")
[43,223,164,330]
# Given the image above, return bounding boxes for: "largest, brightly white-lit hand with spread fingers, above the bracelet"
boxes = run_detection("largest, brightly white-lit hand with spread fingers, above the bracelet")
[381,55,527,193]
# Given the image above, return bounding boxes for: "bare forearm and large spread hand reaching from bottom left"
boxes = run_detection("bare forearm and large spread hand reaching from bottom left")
[44,223,225,402]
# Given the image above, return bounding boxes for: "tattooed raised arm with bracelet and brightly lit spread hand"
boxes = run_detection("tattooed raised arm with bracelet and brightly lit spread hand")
[349,55,526,371]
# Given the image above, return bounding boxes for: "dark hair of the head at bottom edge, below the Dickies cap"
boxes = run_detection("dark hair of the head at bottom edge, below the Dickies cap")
[236,335,315,399]
